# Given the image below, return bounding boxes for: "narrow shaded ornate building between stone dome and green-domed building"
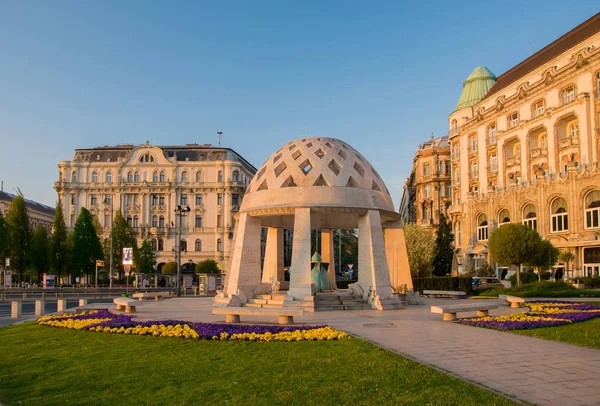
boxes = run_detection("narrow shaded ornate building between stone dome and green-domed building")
[398,136,452,229]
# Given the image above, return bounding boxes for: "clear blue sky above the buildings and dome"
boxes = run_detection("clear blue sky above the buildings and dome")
[0,0,600,206]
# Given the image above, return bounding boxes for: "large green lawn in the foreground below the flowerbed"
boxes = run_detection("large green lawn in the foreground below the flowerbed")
[0,322,514,405]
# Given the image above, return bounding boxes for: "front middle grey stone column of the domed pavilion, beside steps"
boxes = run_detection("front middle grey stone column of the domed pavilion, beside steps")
[288,207,312,300]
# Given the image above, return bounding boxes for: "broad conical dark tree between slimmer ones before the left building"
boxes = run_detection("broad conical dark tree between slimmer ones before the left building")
[72,207,103,277]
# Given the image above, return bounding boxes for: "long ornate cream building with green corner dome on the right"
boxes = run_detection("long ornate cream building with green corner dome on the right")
[448,14,600,276]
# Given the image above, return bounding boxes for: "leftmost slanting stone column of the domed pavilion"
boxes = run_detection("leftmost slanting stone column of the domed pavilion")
[219,213,261,303]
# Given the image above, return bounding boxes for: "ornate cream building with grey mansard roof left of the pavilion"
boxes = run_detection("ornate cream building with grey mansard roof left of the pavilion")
[54,143,256,268]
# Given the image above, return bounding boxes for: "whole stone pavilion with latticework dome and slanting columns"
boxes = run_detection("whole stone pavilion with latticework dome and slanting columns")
[215,137,412,311]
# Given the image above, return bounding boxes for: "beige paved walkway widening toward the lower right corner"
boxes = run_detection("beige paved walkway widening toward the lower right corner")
[5,298,600,406]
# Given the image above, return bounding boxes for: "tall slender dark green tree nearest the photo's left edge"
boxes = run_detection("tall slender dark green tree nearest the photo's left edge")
[6,195,32,282]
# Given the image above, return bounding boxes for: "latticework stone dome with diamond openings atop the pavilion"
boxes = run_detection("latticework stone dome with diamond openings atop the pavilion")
[240,137,394,212]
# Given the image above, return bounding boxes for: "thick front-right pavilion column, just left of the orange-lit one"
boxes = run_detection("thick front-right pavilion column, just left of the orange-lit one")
[360,210,392,299]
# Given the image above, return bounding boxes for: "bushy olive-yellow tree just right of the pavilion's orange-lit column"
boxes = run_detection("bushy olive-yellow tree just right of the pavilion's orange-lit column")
[403,224,435,277]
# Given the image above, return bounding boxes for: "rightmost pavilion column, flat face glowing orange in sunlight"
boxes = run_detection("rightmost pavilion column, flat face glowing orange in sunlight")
[385,220,413,290]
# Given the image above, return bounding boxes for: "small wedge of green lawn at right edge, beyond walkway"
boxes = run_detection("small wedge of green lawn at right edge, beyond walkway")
[514,302,600,348]
